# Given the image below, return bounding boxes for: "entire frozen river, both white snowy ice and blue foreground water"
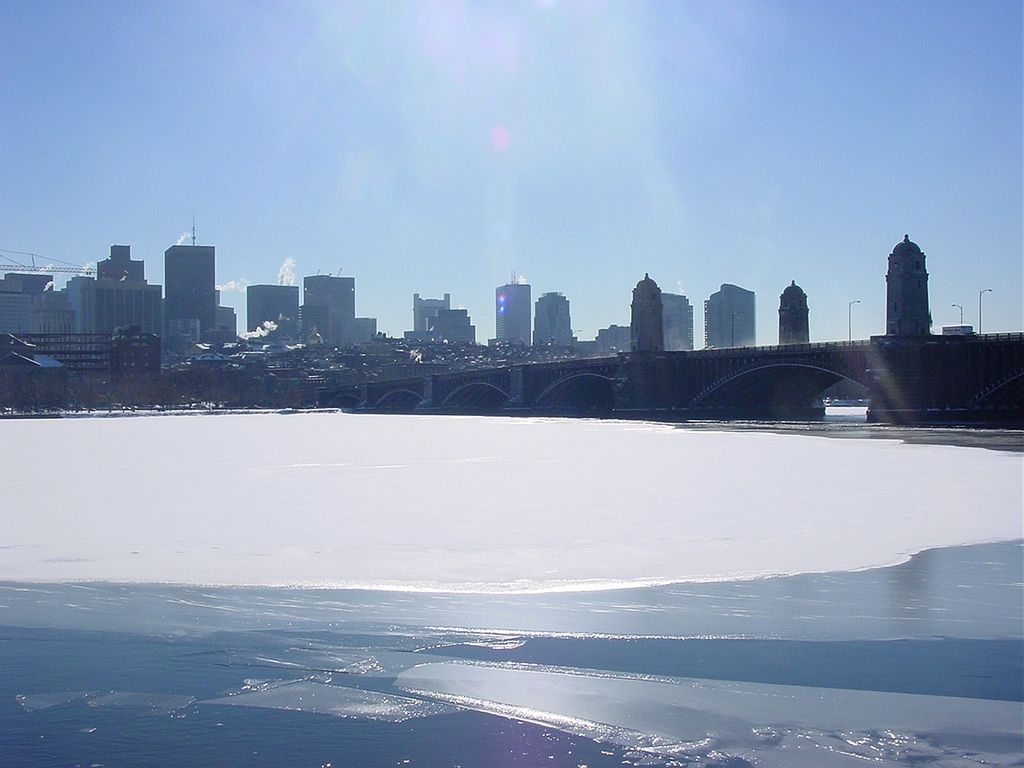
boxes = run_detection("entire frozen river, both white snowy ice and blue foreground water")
[0,414,1024,768]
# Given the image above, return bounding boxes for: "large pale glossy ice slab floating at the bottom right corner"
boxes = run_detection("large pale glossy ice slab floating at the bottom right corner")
[397,664,1024,766]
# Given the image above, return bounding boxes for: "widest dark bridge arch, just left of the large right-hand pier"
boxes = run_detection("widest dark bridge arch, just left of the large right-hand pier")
[688,361,867,418]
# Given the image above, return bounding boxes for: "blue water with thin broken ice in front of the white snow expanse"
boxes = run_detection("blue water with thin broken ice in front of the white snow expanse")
[0,542,1024,766]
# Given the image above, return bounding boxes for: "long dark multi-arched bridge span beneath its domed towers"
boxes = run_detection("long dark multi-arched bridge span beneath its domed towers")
[319,334,1024,426]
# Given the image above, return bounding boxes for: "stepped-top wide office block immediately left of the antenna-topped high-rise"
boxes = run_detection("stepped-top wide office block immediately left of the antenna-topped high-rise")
[63,246,163,336]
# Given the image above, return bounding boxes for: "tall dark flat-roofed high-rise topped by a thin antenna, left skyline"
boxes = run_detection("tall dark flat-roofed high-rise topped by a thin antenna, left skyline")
[164,246,217,344]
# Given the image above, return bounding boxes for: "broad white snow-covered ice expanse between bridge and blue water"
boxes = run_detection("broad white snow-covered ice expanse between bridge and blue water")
[0,413,1022,592]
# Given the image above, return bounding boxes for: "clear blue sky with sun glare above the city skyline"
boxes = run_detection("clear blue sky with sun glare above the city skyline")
[0,0,1022,346]
